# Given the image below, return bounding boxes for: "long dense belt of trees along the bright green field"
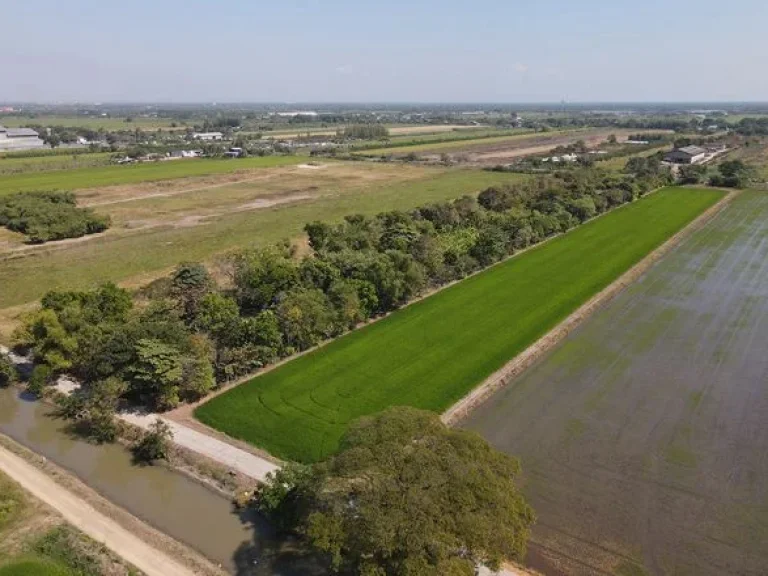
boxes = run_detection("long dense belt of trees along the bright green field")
[14,169,665,421]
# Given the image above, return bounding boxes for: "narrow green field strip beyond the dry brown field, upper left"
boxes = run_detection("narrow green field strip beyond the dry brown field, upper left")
[0,156,306,196]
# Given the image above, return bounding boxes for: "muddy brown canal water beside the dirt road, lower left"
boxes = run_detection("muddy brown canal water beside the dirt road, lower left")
[0,388,318,576]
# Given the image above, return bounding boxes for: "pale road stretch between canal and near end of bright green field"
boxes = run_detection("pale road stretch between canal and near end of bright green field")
[120,413,279,482]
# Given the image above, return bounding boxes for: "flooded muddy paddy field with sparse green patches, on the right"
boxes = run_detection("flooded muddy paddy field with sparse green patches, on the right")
[464,191,768,576]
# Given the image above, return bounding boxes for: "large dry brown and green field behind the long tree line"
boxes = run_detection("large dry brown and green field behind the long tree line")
[0,161,521,312]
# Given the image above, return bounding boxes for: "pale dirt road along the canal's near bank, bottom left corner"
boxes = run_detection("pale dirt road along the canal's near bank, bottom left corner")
[0,447,195,576]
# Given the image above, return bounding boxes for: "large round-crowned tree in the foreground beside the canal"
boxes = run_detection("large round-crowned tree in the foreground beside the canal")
[257,408,534,576]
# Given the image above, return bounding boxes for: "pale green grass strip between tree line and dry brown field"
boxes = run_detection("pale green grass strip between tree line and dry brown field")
[0,168,523,308]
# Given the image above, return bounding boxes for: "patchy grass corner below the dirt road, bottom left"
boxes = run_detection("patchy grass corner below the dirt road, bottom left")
[0,472,126,576]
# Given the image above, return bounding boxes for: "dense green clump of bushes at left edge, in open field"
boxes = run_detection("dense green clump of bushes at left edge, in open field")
[0,192,110,244]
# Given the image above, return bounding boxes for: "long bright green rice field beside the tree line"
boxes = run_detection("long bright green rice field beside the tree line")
[195,188,723,462]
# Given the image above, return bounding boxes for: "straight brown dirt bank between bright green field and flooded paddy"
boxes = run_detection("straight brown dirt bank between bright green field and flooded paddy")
[441,190,739,426]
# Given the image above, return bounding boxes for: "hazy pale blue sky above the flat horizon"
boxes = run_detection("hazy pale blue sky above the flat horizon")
[0,0,768,102]
